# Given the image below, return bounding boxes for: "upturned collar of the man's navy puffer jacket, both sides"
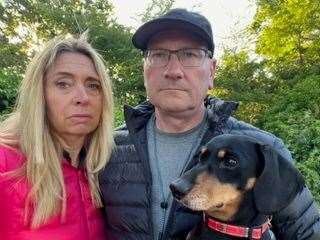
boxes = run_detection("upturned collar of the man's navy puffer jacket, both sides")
[124,97,239,132]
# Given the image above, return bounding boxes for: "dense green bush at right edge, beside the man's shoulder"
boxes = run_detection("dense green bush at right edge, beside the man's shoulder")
[259,75,320,202]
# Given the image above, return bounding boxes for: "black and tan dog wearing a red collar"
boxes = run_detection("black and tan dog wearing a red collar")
[170,134,305,240]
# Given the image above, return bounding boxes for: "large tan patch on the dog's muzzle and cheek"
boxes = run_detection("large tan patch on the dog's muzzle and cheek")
[181,173,243,221]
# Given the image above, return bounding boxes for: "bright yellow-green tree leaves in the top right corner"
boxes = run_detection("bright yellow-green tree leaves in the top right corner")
[251,0,320,78]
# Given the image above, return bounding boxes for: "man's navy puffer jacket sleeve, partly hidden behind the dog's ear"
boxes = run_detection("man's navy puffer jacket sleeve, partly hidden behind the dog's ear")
[228,118,320,240]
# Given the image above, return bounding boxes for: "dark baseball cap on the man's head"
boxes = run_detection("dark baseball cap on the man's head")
[132,8,214,53]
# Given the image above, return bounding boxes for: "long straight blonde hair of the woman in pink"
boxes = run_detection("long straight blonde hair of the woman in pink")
[0,33,114,228]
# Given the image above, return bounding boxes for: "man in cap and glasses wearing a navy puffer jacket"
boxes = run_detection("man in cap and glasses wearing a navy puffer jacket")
[100,9,320,240]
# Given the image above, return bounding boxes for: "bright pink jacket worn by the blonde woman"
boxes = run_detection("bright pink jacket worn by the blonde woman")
[0,146,107,240]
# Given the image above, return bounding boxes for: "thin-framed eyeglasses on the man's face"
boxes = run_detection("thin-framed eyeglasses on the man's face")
[143,48,213,68]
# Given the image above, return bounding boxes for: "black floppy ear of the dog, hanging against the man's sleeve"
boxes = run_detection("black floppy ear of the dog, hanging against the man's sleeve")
[253,144,304,215]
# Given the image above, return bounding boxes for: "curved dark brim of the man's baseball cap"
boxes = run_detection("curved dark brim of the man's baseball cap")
[132,19,213,51]
